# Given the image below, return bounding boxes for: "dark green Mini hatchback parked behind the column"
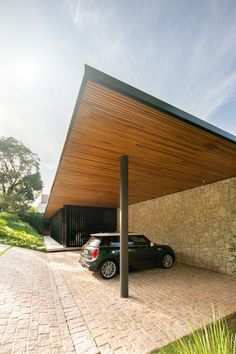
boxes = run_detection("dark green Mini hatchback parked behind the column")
[80,233,175,279]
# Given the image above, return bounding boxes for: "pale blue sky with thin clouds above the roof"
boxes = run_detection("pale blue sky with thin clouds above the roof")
[0,0,236,192]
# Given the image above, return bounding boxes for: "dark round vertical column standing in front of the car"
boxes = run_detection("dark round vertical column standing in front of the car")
[120,155,128,297]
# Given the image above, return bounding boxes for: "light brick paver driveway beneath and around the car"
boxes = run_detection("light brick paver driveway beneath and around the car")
[0,248,236,354]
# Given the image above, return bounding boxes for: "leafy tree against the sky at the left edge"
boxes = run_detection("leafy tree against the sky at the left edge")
[0,137,43,212]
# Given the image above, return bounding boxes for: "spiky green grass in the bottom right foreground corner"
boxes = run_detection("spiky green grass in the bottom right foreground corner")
[152,314,236,354]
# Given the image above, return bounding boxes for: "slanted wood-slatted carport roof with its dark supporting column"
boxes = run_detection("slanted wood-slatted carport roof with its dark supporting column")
[45,66,236,297]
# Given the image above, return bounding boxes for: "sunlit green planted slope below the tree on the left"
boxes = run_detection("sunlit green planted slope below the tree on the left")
[0,212,46,252]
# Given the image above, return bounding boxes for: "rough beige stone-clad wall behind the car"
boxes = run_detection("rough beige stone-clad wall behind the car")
[129,178,236,274]
